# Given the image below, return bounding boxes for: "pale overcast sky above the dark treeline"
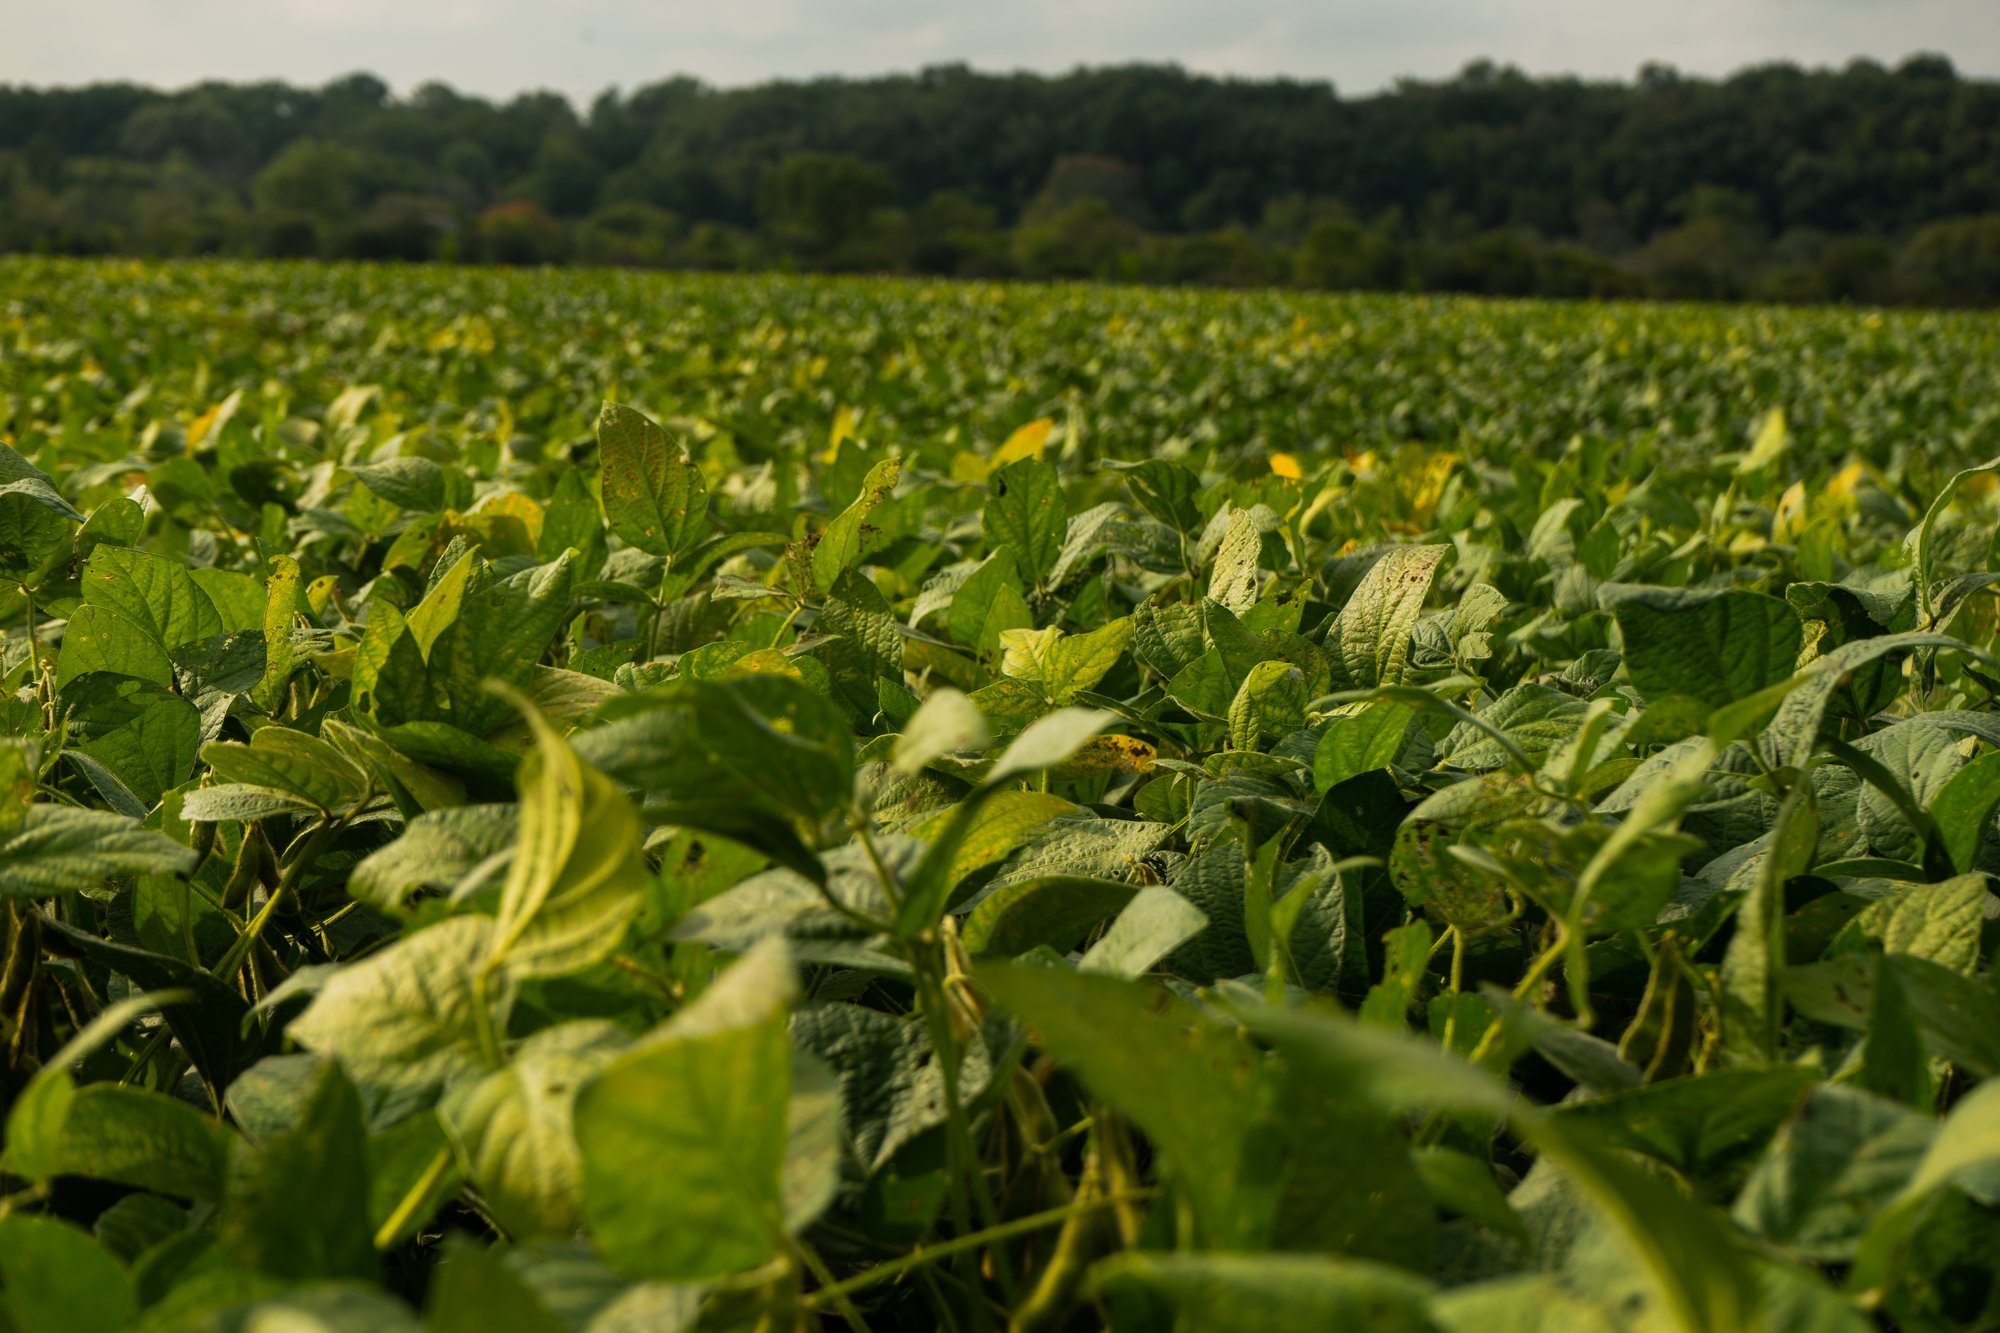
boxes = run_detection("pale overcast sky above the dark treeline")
[0,0,2000,102]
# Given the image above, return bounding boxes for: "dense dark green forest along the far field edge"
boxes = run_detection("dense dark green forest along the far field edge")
[0,56,2000,304]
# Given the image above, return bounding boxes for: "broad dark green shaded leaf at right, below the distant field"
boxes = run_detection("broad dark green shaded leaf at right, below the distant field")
[1600,584,1802,709]
